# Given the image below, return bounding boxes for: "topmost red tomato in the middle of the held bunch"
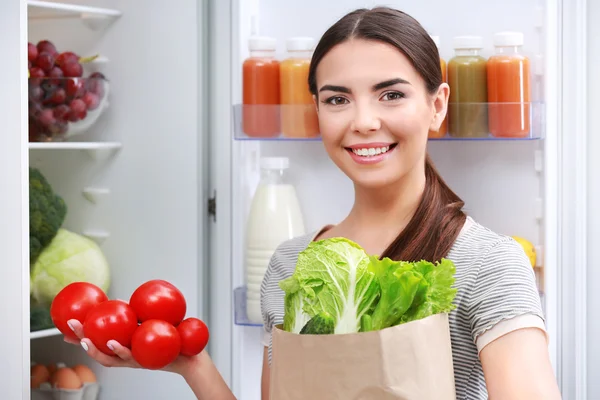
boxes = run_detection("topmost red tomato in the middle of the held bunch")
[129,279,186,326]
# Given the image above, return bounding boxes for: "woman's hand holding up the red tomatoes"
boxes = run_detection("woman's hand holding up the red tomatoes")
[64,319,197,375]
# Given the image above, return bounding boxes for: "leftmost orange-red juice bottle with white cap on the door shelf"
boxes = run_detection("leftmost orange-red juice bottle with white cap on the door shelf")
[242,36,281,137]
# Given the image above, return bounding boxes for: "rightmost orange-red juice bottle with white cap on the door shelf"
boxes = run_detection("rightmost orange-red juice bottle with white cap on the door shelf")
[487,32,531,137]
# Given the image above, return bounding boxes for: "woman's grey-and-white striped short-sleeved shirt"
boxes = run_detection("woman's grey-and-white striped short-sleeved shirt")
[261,217,545,399]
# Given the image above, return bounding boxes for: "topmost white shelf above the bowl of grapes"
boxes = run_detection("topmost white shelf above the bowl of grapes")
[27,0,121,30]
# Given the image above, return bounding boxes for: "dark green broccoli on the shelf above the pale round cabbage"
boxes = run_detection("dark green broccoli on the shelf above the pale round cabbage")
[29,167,67,265]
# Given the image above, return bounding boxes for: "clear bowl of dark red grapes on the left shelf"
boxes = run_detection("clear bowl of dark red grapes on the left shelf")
[28,40,109,142]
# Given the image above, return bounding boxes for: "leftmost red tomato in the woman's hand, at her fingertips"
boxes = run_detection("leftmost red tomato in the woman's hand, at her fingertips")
[50,282,108,340]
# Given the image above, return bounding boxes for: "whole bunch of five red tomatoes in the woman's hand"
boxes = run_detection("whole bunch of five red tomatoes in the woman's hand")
[50,279,209,369]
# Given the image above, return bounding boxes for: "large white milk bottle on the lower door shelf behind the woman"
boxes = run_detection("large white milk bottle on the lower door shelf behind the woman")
[245,157,305,323]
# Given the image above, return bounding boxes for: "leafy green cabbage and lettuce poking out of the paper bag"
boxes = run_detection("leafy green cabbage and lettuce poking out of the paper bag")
[279,238,456,334]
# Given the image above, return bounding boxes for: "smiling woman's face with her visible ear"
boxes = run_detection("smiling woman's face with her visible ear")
[315,39,448,188]
